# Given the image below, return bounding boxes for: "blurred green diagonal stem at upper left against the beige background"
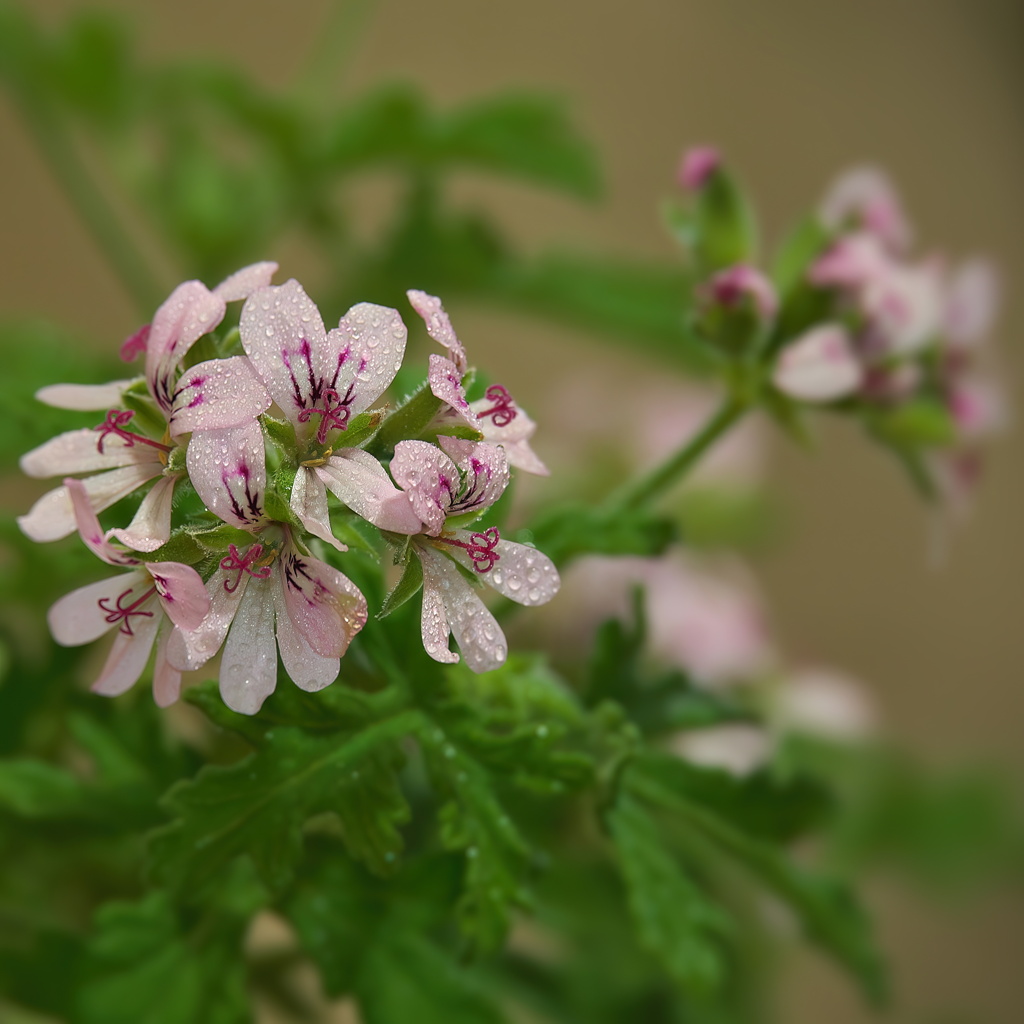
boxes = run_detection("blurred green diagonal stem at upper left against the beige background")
[13,88,165,317]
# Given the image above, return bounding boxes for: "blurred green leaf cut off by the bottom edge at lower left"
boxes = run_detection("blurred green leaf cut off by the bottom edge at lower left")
[71,892,251,1024]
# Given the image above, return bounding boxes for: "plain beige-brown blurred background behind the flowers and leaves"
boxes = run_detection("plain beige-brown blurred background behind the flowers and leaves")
[0,0,1024,1024]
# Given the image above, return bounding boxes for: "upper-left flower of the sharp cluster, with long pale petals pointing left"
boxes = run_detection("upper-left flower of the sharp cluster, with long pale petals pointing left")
[18,263,276,551]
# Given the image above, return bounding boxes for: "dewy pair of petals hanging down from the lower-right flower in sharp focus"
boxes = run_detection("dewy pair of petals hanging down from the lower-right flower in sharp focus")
[417,546,508,672]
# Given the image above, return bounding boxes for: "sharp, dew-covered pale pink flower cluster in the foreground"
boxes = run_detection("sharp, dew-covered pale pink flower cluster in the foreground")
[18,263,559,714]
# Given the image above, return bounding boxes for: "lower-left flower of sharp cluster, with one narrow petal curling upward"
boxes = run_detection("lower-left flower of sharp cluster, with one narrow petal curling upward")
[47,479,210,708]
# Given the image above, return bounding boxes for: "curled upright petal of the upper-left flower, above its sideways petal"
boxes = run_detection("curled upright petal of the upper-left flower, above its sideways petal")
[145,281,226,415]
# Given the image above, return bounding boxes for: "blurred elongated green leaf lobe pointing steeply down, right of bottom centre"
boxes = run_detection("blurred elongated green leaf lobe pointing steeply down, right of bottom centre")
[604,792,728,993]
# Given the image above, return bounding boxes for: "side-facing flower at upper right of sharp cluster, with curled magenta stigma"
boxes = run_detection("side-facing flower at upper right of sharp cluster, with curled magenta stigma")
[406,289,548,476]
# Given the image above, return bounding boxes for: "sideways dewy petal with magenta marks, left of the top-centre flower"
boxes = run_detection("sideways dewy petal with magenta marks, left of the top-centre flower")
[168,355,270,437]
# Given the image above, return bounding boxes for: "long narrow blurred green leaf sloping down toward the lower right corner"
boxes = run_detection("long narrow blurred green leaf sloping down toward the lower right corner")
[622,760,887,1004]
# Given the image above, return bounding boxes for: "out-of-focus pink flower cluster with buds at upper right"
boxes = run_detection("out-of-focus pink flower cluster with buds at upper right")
[677,147,1006,499]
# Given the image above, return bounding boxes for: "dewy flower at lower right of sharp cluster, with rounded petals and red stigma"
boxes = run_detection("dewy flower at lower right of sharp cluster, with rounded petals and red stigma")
[391,437,559,672]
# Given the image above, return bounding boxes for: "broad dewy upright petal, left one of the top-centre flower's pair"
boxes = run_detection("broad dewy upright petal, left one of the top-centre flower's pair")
[240,280,327,425]
